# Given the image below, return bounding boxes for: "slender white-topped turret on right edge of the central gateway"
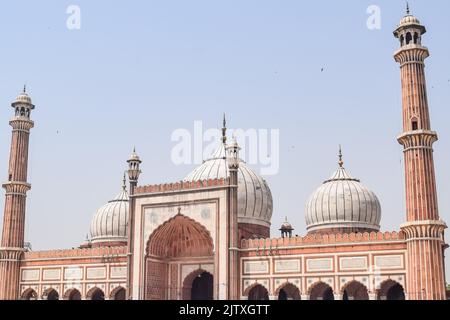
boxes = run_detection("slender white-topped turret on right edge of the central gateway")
[224,134,241,300]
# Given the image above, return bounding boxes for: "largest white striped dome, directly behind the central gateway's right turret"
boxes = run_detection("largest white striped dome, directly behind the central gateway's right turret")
[184,142,273,227]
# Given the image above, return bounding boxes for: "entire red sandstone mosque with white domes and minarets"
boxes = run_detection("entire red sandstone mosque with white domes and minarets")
[0,9,447,300]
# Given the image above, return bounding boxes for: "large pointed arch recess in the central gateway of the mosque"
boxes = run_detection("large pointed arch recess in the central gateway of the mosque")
[145,213,214,300]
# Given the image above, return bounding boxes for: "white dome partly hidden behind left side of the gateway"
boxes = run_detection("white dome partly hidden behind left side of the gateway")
[90,183,129,244]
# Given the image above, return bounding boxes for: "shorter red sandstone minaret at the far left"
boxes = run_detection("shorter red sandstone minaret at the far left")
[0,87,34,300]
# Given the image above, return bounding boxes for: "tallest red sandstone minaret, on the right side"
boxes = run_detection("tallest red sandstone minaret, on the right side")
[394,6,446,300]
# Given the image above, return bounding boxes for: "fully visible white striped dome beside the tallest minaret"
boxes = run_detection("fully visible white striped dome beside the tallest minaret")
[306,149,381,233]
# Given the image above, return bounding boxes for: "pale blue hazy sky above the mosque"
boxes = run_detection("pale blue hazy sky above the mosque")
[0,0,450,280]
